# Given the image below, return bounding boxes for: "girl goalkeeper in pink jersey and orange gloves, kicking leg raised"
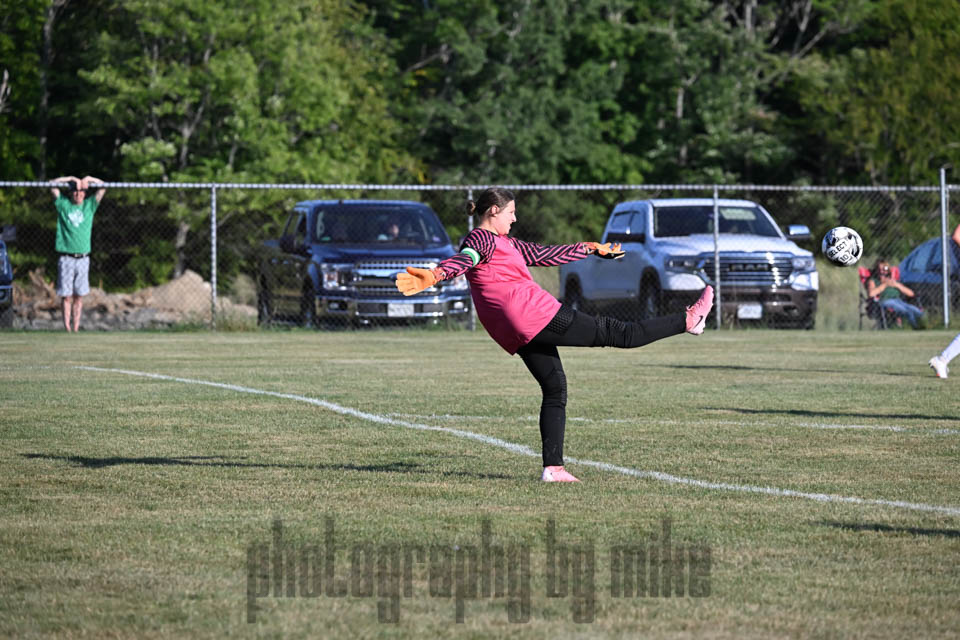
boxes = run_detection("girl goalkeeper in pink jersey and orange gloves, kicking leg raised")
[397,188,713,482]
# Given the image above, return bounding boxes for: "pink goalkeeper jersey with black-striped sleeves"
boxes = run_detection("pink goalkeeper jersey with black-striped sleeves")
[439,229,587,355]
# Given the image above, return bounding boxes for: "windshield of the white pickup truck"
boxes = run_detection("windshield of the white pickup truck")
[653,205,780,238]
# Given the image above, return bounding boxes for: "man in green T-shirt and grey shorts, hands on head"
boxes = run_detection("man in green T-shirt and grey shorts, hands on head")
[50,176,106,332]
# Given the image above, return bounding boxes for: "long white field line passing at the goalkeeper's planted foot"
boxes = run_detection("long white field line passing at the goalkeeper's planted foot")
[76,366,960,516]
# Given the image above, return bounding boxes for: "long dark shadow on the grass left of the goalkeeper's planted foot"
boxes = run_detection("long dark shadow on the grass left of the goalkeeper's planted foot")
[20,453,511,480]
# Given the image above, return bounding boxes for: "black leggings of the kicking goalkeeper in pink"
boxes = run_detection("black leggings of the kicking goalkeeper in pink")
[517,306,686,467]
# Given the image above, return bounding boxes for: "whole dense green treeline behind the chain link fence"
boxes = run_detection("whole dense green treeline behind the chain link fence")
[0,0,960,283]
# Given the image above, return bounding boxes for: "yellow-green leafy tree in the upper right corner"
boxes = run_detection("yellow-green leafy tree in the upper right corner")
[800,0,960,184]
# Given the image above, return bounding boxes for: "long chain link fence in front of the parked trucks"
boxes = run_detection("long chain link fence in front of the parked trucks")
[0,182,960,330]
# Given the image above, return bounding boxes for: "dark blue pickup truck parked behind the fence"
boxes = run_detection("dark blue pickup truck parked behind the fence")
[257,200,471,327]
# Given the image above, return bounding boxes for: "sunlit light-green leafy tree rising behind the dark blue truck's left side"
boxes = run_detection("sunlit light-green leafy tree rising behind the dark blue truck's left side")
[79,0,416,275]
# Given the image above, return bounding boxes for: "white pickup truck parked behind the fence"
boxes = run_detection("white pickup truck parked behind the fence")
[560,198,819,329]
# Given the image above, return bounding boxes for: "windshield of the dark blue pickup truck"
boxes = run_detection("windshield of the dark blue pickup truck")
[313,206,450,245]
